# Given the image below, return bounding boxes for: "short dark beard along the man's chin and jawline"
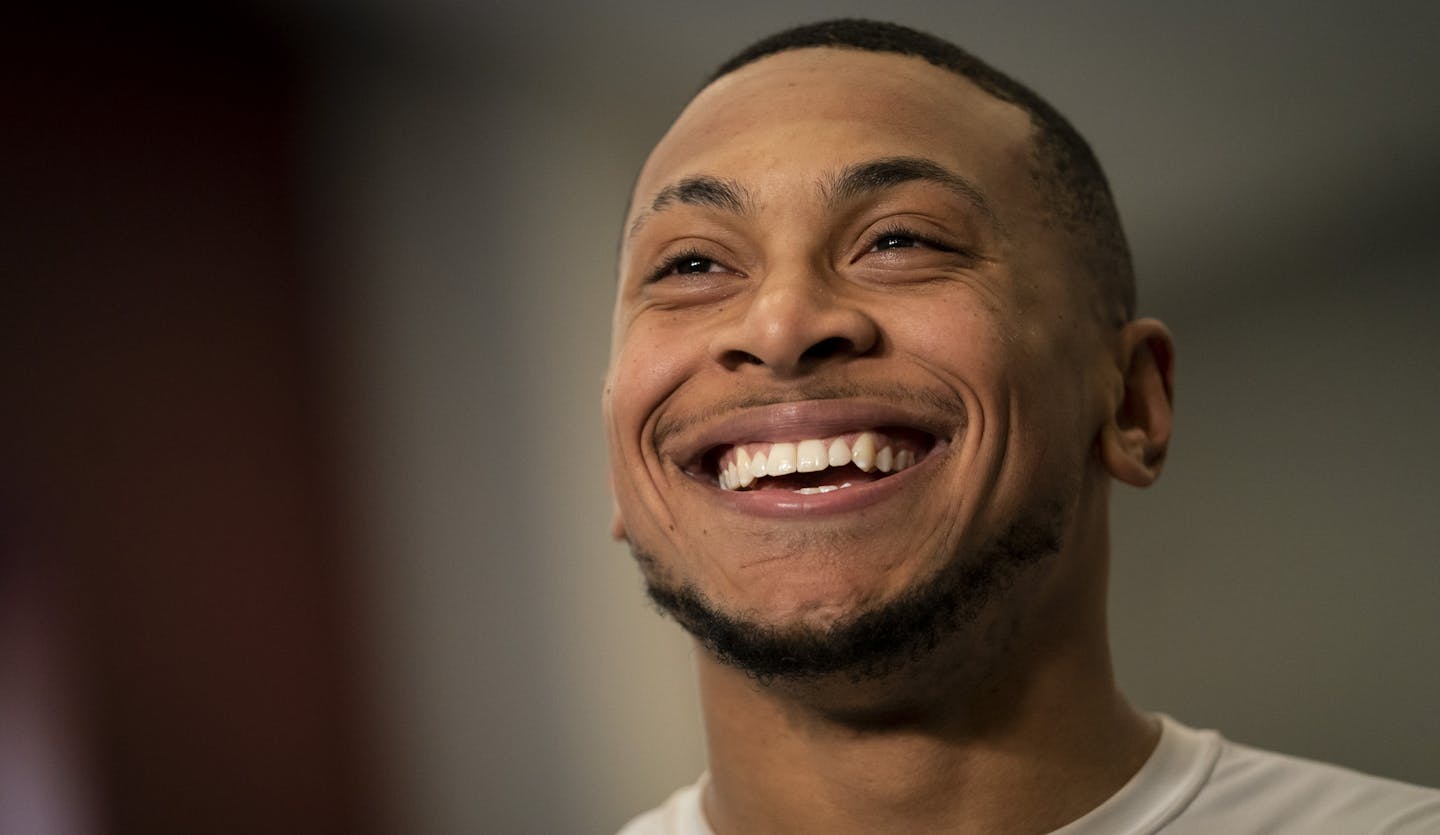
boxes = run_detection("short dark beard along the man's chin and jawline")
[631,501,1064,684]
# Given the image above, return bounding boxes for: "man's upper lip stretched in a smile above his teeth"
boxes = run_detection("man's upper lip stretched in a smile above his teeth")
[670,397,965,472]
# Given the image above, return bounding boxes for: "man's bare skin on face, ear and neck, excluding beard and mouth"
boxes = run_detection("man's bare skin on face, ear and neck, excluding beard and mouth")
[603,49,1174,835]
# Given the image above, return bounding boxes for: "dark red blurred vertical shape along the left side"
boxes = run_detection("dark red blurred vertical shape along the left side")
[0,4,373,834]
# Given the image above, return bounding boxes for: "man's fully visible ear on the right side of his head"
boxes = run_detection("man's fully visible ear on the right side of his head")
[1100,320,1175,487]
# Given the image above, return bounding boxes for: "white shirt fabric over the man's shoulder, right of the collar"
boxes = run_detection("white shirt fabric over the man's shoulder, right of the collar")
[1176,728,1440,835]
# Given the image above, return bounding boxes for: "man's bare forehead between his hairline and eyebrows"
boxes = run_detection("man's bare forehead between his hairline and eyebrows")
[631,48,1032,219]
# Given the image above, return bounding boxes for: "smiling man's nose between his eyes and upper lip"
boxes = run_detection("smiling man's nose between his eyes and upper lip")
[710,262,880,377]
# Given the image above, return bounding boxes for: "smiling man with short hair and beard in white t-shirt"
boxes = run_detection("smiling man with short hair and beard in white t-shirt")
[603,20,1440,835]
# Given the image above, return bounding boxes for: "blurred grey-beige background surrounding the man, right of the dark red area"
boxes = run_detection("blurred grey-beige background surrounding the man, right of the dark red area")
[11,0,1440,834]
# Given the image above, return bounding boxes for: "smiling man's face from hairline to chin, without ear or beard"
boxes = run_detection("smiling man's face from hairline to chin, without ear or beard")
[603,49,1115,665]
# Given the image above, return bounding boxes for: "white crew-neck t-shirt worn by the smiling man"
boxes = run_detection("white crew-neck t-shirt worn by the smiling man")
[619,716,1440,835]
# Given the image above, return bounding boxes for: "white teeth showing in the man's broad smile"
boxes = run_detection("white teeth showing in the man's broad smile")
[720,432,916,492]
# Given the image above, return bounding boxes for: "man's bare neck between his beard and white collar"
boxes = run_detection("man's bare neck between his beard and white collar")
[700,535,1159,835]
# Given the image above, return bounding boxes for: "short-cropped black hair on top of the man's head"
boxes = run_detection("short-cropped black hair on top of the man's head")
[706,19,1135,320]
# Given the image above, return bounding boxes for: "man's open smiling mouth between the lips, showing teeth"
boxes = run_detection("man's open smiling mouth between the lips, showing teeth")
[703,429,936,495]
